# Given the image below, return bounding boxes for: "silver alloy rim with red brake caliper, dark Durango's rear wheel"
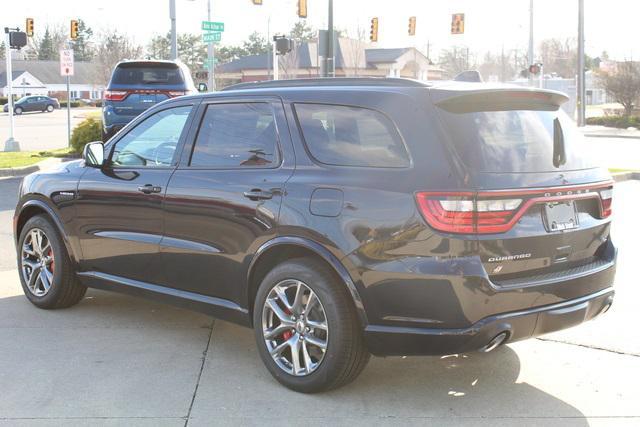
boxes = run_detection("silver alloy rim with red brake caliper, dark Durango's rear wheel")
[262,279,329,376]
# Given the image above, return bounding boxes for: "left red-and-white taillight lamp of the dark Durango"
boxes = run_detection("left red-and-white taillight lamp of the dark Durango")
[416,193,522,234]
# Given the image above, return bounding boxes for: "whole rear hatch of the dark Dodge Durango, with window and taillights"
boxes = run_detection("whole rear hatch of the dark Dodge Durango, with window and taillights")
[418,89,613,287]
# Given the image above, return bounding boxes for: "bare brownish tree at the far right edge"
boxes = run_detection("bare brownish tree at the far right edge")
[599,61,640,116]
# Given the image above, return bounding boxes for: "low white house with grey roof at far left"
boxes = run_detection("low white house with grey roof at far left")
[0,60,104,100]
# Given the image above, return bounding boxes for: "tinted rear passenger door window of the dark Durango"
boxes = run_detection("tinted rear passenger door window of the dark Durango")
[191,103,279,168]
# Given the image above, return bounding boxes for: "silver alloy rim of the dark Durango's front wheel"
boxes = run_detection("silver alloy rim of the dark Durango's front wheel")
[21,228,55,297]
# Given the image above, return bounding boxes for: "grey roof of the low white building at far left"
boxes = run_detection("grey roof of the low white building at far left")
[0,60,96,87]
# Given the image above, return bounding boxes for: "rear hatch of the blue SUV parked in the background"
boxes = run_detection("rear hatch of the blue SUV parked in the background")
[105,61,188,116]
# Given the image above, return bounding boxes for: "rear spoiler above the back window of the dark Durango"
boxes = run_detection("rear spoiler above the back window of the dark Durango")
[432,88,569,113]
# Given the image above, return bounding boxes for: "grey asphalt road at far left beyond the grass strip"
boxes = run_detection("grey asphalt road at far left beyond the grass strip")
[0,108,100,151]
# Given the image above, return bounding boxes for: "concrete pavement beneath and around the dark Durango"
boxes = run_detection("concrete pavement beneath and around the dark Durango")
[0,176,640,427]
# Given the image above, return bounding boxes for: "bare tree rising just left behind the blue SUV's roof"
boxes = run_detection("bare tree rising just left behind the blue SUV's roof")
[93,30,142,85]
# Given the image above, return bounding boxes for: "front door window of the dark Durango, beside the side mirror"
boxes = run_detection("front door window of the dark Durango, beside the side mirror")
[112,106,191,167]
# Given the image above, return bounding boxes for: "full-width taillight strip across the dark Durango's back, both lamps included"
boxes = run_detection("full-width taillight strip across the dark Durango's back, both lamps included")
[416,182,613,234]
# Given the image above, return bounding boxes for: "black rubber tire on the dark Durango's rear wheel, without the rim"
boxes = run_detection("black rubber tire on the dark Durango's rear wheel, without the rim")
[253,258,370,393]
